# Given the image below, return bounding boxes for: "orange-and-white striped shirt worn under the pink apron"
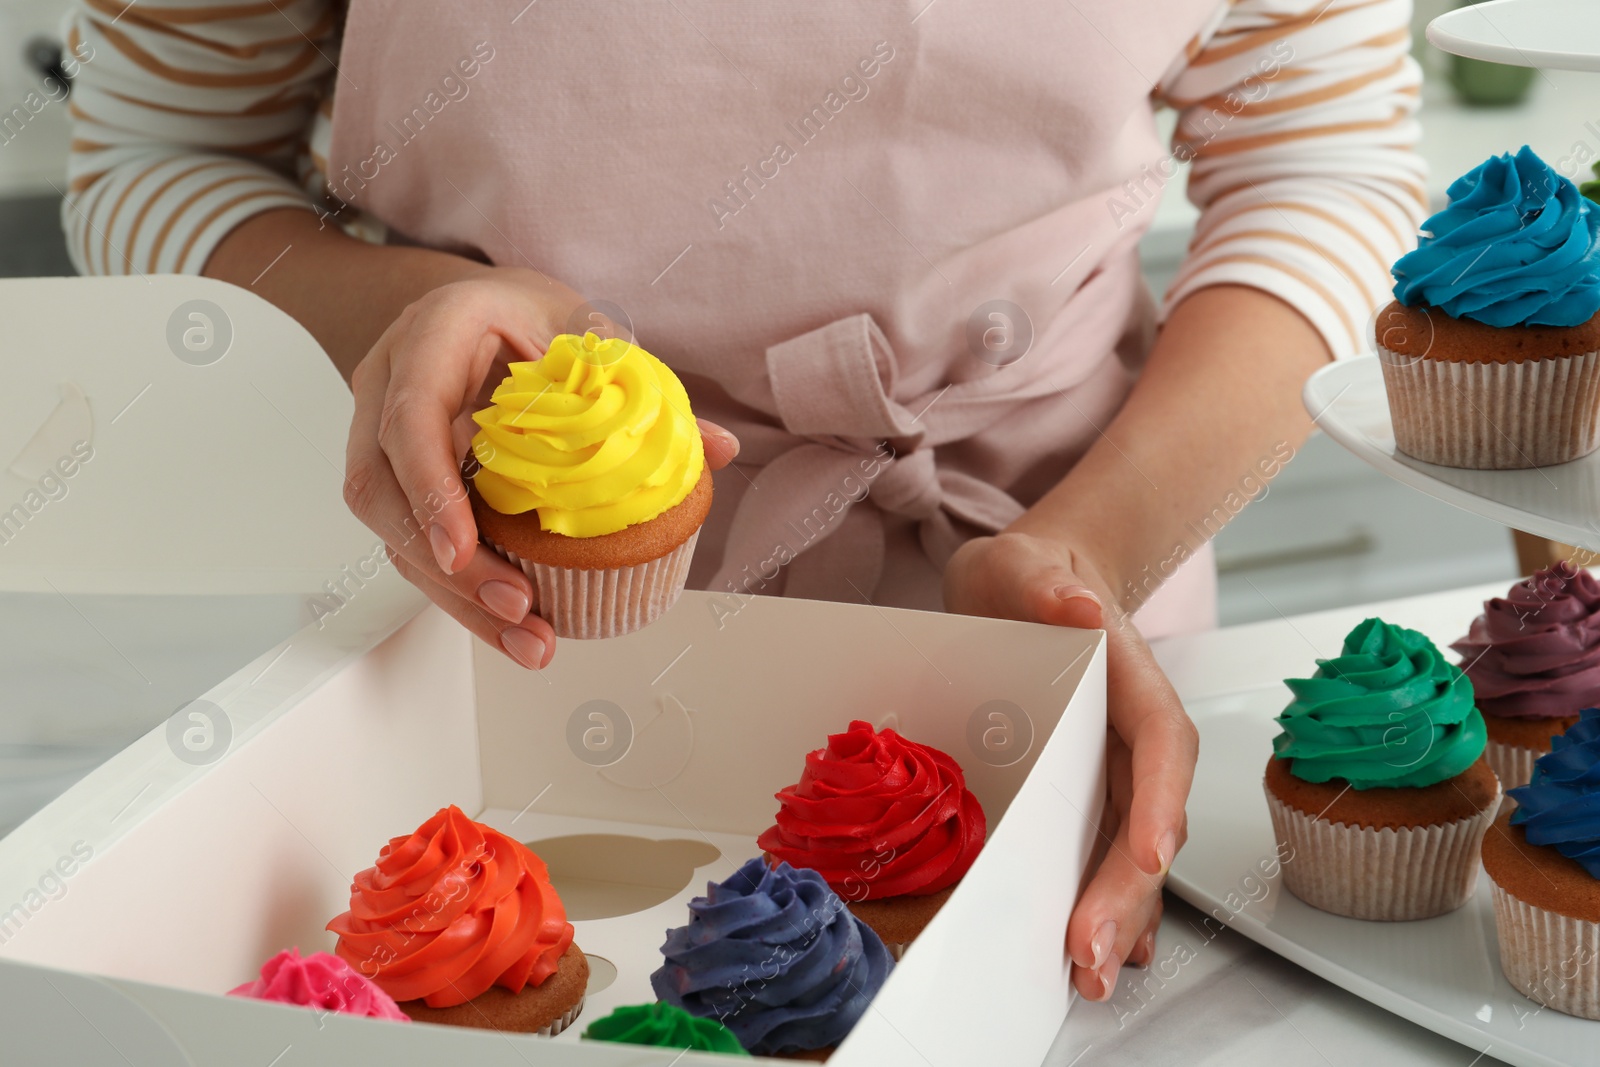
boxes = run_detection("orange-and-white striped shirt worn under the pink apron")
[62,0,1427,357]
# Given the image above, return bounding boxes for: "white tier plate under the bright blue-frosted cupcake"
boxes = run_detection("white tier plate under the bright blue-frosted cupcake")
[1304,358,1600,549]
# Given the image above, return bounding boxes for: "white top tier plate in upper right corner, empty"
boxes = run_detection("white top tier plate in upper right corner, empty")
[1427,0,1600,70]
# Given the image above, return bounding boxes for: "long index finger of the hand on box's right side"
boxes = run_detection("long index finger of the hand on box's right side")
[1106,625,1200,875]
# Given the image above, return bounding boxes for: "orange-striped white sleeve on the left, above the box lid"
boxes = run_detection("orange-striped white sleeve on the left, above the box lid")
[61,0,338,274]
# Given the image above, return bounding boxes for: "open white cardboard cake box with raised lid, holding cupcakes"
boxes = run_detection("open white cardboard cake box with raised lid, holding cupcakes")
[0,278,1106,1067]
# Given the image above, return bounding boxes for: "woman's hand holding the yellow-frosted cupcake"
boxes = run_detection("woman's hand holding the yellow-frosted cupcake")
[344,267,739,670]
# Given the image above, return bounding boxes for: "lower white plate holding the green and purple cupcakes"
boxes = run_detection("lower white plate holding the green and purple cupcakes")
[1170,686,1600,1067]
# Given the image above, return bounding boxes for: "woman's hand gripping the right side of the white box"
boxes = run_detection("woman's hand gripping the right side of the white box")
[944,533,1200,1000]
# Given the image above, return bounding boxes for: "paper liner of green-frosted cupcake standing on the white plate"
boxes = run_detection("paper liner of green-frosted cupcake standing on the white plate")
[1267,780,1502,921]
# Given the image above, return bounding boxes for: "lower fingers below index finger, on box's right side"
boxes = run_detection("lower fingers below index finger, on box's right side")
[1067,832,1162,1000]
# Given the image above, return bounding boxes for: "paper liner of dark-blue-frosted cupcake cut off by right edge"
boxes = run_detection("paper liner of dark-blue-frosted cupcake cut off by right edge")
[1491,880,1600,1019]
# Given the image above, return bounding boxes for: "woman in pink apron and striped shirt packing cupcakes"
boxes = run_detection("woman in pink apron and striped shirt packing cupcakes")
[64,0,1424,998]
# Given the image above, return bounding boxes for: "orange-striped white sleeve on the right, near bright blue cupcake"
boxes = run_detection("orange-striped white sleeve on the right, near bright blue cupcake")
[1160,0,1427,357]
